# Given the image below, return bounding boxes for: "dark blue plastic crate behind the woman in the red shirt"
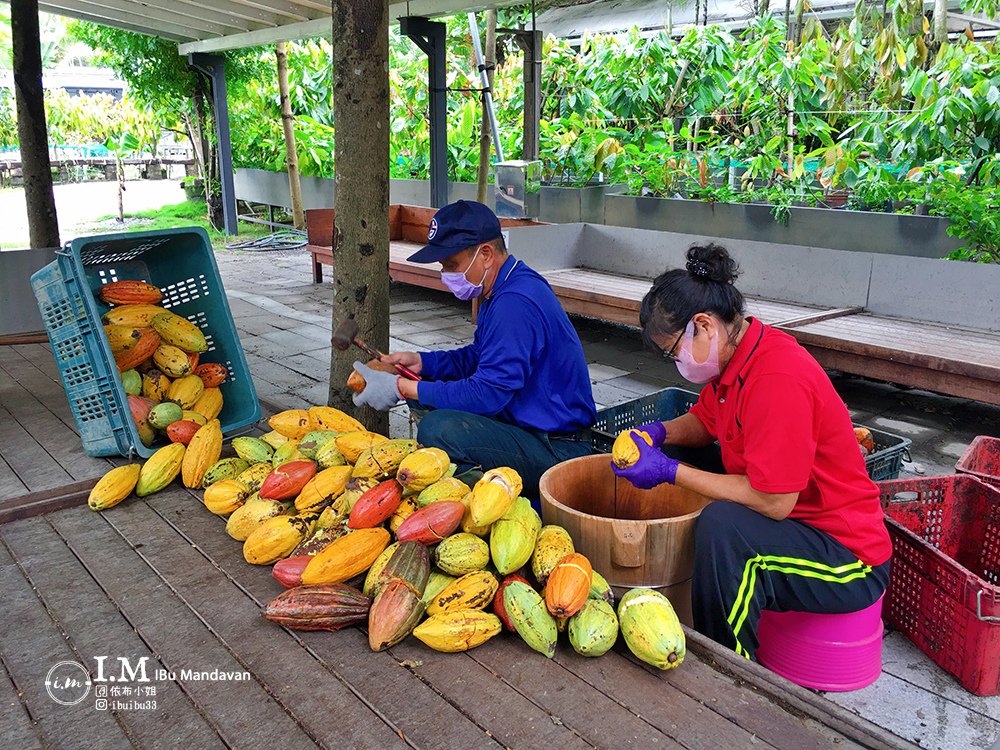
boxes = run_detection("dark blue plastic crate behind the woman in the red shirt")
[591,388,911,482]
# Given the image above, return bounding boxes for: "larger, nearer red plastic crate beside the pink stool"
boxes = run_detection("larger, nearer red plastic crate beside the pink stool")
[879,475,1000,695]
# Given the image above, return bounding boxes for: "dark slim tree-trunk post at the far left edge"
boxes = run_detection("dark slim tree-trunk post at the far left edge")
[10,0,59,253]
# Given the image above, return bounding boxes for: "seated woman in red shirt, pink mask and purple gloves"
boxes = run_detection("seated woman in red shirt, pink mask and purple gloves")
[615,245,892,658]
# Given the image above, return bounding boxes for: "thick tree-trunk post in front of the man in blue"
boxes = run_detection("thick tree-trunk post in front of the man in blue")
[328,0,389,435]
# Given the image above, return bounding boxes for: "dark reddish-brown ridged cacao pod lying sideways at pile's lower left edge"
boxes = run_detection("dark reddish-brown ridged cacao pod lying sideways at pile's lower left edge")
[264,583,371,630]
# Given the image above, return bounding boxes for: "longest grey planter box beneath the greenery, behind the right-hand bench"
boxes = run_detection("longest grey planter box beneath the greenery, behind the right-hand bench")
[604,195,963,258]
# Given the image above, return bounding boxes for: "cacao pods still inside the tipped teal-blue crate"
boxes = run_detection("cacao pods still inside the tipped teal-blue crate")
[97,280,229,448]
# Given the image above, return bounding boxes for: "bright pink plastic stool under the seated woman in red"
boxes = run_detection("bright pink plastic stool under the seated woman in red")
[756,597,883,691]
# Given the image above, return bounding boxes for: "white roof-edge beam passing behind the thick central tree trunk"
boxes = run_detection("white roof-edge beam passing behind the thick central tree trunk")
[177,0,520,55]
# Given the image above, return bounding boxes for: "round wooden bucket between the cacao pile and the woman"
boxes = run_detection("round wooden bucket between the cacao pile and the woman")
[539,454,711,625]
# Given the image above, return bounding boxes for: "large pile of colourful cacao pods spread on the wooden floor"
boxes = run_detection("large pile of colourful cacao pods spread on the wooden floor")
[90,407,685,669]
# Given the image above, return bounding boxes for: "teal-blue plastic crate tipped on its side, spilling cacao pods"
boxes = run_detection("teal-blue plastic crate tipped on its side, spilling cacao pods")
[31,227,261,457]
